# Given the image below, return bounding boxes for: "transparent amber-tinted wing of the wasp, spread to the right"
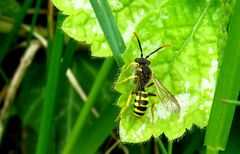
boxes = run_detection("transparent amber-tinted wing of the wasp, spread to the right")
[152,74,180,113]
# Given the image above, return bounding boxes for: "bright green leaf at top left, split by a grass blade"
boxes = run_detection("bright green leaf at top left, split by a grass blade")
[52,0,165,57]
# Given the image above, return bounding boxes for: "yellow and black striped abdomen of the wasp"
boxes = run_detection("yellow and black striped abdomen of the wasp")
[134,91,149,118]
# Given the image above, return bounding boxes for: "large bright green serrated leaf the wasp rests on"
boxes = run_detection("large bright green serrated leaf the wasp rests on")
[116,0,222,143]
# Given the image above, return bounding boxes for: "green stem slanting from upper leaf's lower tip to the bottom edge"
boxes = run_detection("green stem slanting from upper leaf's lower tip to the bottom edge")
[63,57,114,154]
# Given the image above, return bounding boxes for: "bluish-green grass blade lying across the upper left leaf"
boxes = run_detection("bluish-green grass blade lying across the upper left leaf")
[90,0,126,66]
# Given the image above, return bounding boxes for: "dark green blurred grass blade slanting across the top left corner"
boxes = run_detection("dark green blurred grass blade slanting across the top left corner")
[0,0,33,66]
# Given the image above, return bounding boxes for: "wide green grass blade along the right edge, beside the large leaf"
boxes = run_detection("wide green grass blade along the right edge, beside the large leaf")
[205,0,240,153]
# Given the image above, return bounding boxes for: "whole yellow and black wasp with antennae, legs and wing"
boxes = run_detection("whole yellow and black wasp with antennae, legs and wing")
[116,32,180,121]
